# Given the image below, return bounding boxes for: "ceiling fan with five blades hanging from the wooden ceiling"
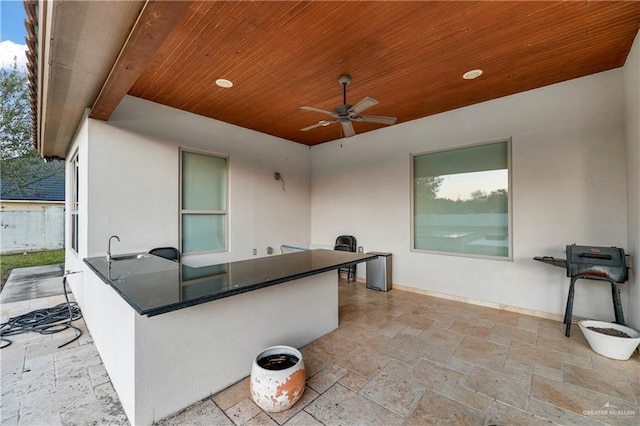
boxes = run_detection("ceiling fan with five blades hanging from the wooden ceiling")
[300,75,398,138]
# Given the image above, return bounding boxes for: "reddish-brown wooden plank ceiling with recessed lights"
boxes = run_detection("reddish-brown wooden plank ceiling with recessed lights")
[100,1,640,145]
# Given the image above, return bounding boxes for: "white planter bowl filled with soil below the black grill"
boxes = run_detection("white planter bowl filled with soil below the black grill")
[578,320,640,361]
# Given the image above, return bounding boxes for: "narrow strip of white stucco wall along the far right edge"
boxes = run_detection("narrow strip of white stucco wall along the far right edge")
[622,33,640,330]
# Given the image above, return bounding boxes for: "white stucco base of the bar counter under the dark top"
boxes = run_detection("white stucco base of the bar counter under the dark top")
[80,270,338,425]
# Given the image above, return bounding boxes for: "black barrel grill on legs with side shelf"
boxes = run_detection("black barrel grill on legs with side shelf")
[533,244,629,337]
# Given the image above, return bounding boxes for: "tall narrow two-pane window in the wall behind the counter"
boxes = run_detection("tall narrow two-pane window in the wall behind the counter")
[180,151,227,254]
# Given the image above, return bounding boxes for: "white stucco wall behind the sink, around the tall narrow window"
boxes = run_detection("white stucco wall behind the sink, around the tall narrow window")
[80,97,311,264]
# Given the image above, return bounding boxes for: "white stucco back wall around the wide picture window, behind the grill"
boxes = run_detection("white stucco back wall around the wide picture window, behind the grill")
[311,69,628,319]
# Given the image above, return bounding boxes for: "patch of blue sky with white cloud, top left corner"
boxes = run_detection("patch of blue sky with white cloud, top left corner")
[0,0,27,67]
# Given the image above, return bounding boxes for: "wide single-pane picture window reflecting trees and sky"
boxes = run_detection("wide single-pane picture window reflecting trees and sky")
[412,141,511,259]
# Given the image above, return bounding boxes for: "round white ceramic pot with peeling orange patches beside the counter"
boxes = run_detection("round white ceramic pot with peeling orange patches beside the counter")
[250,346,306,413]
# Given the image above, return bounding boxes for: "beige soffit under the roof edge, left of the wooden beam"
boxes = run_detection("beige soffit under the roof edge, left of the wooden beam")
[39,1,145,158]
